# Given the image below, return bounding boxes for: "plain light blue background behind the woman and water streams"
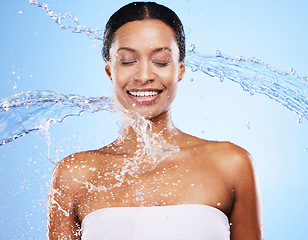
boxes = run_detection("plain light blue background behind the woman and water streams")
[0,0,308,239]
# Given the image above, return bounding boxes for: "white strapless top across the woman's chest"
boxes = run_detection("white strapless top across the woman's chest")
[81,204,230,240]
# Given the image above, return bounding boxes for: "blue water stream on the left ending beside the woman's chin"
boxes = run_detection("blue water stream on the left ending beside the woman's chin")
[0,90,113,146]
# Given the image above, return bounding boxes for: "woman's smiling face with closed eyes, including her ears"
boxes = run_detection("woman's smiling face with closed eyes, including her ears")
[106,20,185,119]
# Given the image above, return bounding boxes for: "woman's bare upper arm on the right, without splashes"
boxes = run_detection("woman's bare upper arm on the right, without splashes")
[229,148,263,240]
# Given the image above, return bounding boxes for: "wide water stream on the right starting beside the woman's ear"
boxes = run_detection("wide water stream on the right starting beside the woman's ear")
[185,46,308,122]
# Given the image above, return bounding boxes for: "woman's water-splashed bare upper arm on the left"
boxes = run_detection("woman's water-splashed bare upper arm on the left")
[47,159,81,240]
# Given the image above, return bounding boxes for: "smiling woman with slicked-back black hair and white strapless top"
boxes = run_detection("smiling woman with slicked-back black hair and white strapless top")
[48,2,262,240]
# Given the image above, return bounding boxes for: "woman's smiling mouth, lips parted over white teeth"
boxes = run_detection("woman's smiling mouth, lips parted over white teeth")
[127,89,162,104]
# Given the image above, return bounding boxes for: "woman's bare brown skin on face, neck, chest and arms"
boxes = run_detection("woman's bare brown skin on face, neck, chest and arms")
[48,20,262,240]
